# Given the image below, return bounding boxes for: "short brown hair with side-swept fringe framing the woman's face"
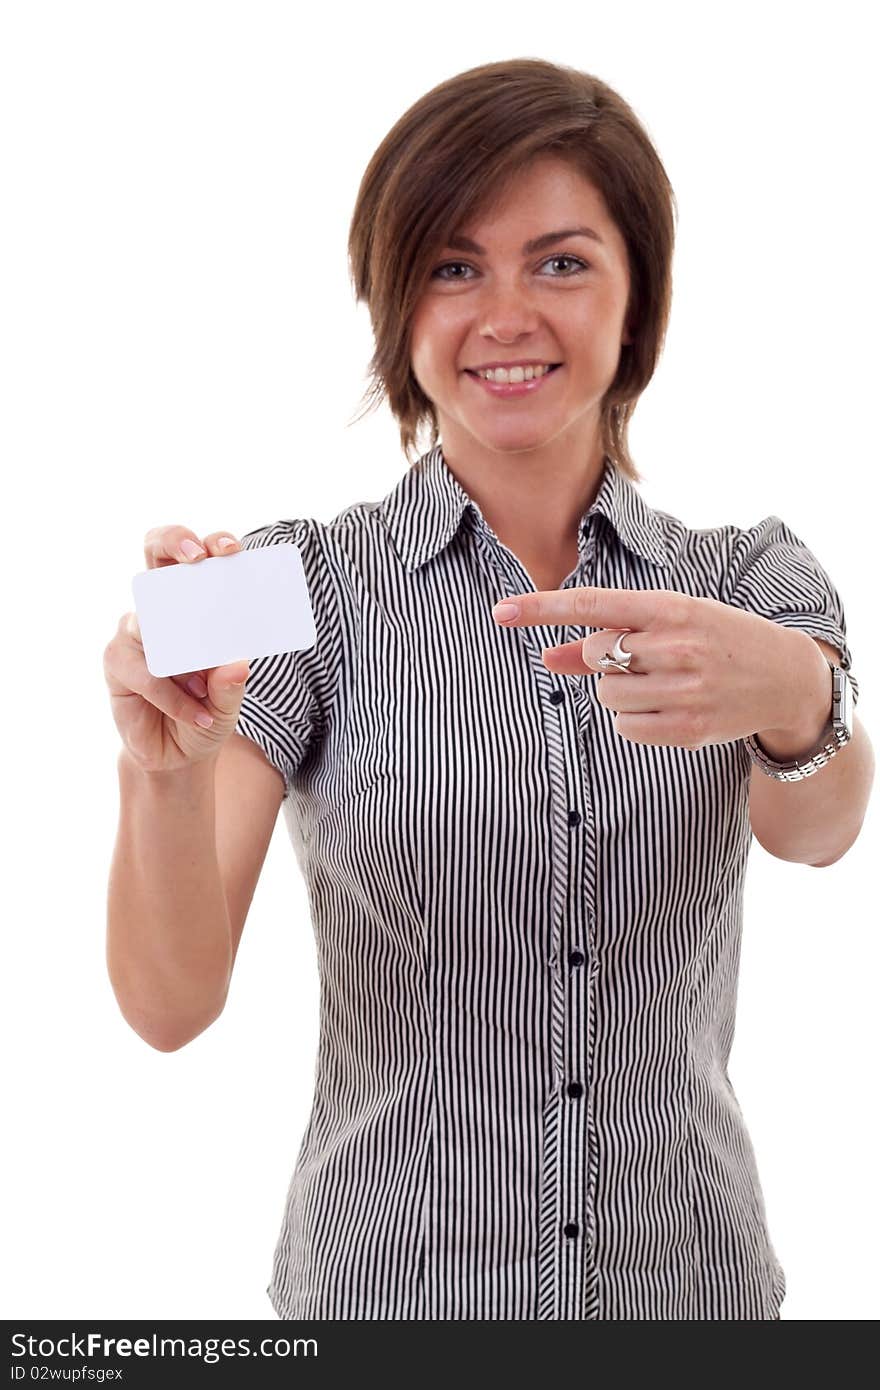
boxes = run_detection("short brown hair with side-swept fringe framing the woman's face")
[349,58,677,482]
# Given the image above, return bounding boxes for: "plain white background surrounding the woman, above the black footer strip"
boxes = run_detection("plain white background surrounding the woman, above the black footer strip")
[0,0,880,1319]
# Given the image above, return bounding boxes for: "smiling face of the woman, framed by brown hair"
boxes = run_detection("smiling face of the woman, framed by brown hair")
[412,156,630,452]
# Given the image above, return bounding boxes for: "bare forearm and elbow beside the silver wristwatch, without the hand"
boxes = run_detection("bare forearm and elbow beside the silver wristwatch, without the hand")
[749,637,874,866]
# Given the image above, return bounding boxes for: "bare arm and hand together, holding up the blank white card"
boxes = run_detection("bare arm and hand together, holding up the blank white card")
[104,525,284,1052]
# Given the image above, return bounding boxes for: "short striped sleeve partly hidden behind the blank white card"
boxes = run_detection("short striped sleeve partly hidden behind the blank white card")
[229,520,325,798]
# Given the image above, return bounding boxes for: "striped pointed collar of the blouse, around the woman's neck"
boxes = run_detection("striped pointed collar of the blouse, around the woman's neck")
[380,445,670,573]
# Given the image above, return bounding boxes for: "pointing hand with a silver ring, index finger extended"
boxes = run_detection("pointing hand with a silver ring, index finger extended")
[492,588,824,749]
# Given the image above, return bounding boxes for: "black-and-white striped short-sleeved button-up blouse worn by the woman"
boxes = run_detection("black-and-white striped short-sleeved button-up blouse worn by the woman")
[238,445,858,1321]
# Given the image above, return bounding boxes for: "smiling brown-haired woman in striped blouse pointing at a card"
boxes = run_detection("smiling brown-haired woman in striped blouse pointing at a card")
[107,60,870,1319]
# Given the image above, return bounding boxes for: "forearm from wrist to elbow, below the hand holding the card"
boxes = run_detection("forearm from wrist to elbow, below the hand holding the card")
[107,752,231,1051]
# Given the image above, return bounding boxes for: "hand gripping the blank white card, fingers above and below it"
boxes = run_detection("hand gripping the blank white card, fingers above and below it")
[104,525,250,771]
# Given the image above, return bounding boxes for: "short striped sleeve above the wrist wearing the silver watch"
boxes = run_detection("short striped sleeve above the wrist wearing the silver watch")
[724,516,859,708]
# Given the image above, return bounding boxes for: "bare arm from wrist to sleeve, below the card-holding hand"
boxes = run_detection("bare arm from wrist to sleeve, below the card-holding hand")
[107,733,284,1052]
